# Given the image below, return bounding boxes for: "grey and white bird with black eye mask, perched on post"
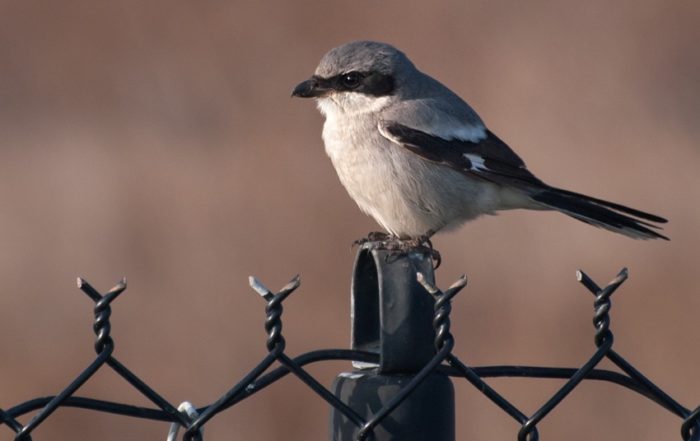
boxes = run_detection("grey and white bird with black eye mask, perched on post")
[292,41,668,244]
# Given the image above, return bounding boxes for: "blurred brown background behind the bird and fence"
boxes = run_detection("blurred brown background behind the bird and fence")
[0,0,700,441]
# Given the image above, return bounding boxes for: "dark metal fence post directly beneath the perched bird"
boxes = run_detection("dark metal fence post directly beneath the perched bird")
[330,243,455,441]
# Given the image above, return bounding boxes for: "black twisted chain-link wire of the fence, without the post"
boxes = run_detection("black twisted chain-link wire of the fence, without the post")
[0,269,700,441]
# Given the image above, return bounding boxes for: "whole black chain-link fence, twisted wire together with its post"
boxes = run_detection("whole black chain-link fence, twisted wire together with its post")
[0,243,700,441]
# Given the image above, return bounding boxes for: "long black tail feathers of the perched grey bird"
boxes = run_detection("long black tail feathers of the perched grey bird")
[531,187,669,240]
